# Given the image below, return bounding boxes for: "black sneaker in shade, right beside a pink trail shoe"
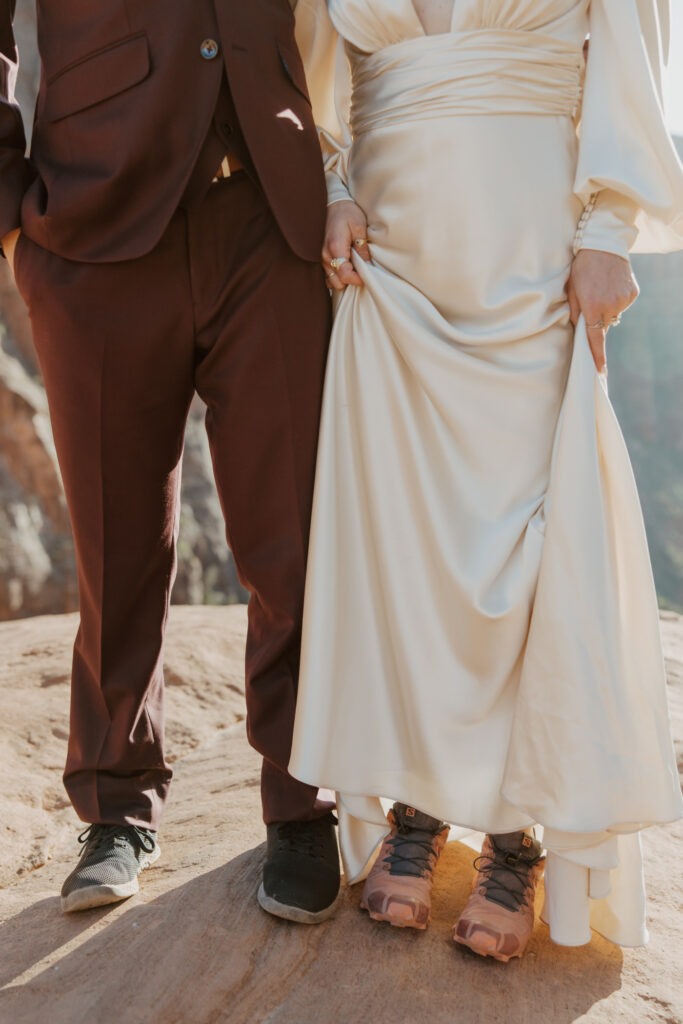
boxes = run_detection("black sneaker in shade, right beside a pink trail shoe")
[258,814,340,925]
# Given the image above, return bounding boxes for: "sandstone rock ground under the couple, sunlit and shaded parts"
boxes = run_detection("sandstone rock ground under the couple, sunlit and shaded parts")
[0,607,683,1024]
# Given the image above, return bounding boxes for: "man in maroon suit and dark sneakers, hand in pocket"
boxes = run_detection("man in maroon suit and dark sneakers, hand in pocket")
[0,0,339,923]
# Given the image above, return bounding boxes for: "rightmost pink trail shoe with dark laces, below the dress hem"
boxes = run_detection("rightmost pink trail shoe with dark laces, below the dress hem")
[453,833,545,962]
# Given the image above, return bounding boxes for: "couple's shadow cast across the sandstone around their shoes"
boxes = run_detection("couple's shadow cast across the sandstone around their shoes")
[0,843,623,1024]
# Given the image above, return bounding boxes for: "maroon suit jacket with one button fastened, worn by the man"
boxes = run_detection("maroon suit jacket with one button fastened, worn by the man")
[0,0,326,262]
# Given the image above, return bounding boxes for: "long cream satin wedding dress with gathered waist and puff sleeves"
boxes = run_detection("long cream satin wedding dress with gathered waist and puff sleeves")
[290,0,683,958]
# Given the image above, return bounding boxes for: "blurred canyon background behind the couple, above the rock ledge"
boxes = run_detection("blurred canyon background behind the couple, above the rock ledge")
[0,0,683,620]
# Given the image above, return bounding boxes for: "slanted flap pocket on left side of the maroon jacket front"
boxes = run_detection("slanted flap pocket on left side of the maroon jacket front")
[44,34,150,121]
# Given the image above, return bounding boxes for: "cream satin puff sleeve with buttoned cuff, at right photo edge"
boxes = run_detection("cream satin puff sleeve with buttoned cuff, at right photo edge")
[574,0,683,258]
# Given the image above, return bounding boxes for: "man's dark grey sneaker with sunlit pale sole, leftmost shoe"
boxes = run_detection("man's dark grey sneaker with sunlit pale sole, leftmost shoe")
[61,825,161,913]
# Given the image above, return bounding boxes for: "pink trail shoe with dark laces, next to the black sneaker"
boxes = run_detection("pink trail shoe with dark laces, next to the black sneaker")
[360,804,449,930]
